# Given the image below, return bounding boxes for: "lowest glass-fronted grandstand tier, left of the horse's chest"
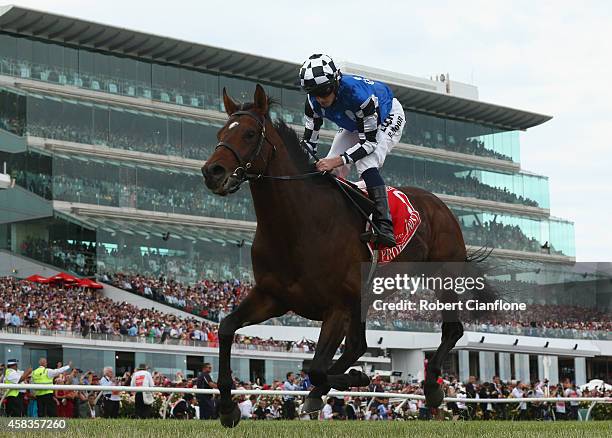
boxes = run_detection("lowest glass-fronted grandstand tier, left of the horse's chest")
[0,216,252,284]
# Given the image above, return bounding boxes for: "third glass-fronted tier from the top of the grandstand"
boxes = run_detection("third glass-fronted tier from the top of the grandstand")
[0,145,575,264]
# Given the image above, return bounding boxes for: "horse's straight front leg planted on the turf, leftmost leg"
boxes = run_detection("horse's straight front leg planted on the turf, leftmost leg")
[217,286,286,427]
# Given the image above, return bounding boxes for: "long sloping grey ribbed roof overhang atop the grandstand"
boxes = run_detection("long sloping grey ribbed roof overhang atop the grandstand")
[0,6,551,130]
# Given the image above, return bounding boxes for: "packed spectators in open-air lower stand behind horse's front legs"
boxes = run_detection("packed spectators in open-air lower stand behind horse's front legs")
[0,277,308,352]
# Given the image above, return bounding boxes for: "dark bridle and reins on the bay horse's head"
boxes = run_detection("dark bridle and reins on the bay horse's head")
[215,110,321,193]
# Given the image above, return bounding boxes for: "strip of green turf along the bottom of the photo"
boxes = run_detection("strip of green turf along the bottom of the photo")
[5,419,612,438]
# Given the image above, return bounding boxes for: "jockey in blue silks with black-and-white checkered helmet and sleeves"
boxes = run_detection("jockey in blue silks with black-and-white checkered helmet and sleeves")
[300,54,406,247]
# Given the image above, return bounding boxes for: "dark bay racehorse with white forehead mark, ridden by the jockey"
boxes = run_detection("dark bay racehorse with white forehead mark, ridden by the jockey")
[202,85,467,427]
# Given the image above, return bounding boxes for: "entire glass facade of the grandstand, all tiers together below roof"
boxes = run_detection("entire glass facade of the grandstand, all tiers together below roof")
[0,33,575,281]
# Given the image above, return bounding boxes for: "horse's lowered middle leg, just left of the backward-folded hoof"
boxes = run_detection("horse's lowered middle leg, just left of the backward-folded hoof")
[303,310,348,412]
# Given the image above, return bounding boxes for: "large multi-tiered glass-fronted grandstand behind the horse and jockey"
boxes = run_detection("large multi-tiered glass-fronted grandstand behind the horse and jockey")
[0,6,612,384]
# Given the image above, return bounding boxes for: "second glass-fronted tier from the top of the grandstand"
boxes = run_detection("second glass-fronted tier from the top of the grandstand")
[0,87,549,208]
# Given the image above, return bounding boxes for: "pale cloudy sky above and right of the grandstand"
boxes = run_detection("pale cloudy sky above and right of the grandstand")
[7,0,612,261]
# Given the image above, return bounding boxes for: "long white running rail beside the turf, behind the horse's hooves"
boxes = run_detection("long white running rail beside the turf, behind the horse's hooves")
[0,383,612,420]
